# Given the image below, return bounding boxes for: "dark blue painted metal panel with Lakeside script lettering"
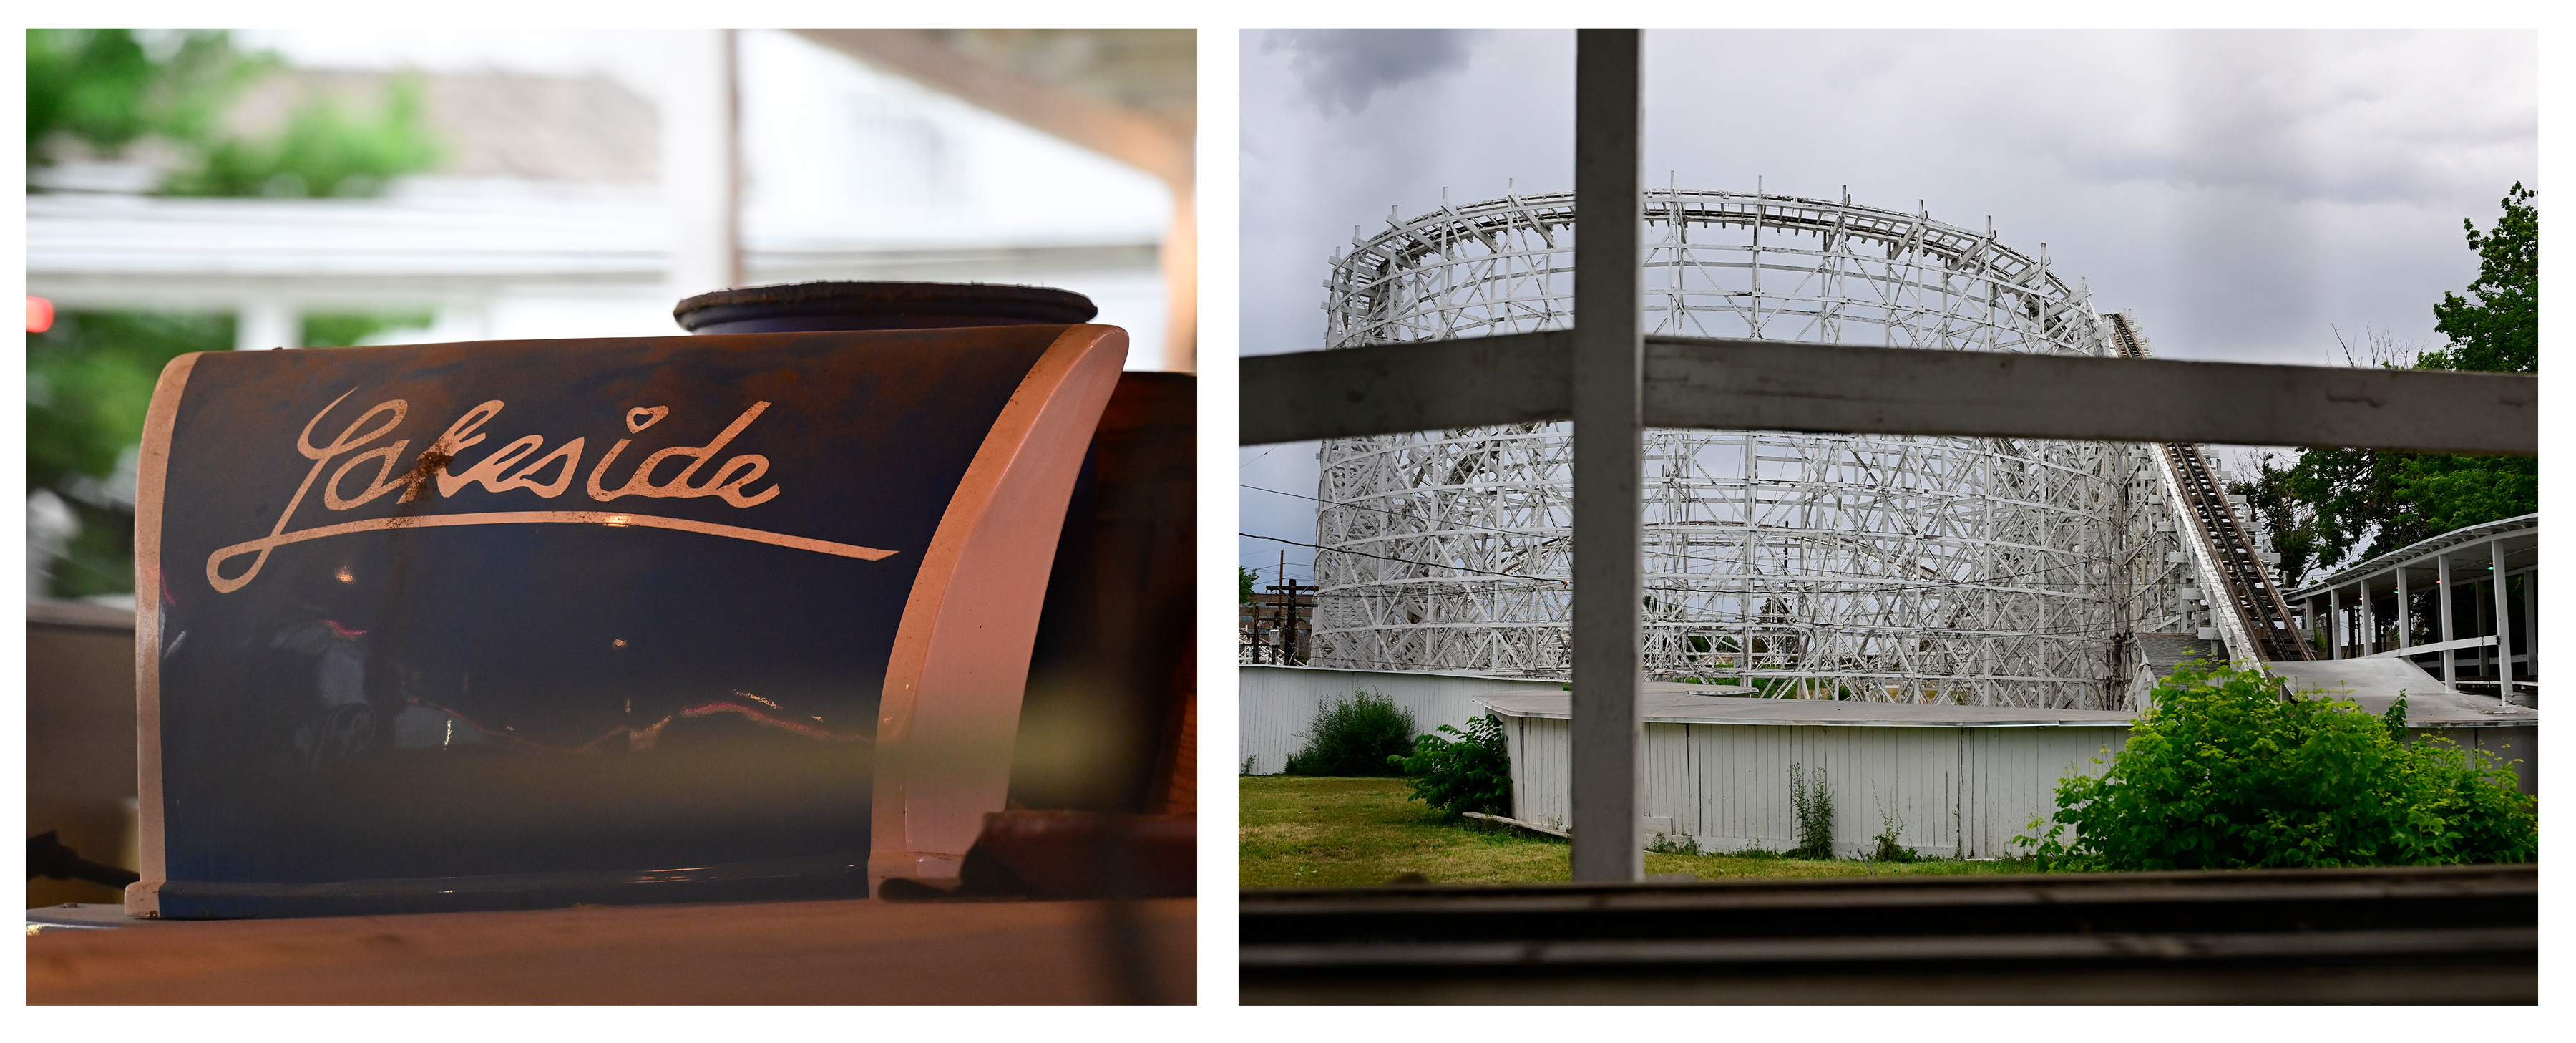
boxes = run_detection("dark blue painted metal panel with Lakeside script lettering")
[142,324,1064,917]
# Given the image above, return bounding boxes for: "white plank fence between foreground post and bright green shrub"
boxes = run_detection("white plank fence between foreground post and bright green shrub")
[1502,716,2128,858]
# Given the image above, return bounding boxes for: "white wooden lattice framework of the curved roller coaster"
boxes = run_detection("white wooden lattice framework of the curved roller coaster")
[1314,190,2197,708]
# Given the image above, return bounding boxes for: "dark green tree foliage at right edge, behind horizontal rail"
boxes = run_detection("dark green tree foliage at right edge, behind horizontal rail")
[2233,183,2540,582]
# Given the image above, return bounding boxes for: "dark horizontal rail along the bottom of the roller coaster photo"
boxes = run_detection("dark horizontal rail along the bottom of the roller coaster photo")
[1236,865,2540,1004]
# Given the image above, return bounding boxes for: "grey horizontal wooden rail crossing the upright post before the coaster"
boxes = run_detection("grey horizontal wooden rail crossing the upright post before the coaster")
[1241,329,2540,456]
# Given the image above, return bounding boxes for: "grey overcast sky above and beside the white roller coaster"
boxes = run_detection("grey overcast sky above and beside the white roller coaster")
[1239,29,2545,582]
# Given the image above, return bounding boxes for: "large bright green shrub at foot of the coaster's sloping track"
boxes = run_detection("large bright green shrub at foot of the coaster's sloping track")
[2014,664,2540,870]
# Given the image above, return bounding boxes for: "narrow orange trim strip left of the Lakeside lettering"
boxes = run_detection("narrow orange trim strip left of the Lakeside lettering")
[126,355,201,917]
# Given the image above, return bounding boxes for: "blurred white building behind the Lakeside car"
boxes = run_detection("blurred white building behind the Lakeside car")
[26,31,1188,368]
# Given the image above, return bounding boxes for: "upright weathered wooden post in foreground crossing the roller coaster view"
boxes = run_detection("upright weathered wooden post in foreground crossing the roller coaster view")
[1571,29,1646,881]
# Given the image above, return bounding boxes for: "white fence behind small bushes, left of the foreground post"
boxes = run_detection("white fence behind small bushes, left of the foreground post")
[1234,664,1563,775]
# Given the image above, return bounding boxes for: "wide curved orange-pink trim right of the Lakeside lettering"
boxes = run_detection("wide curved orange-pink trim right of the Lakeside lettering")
[868,324,1128,893]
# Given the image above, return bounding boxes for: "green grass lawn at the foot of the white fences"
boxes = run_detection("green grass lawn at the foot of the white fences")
[1236,775,2030,888]
